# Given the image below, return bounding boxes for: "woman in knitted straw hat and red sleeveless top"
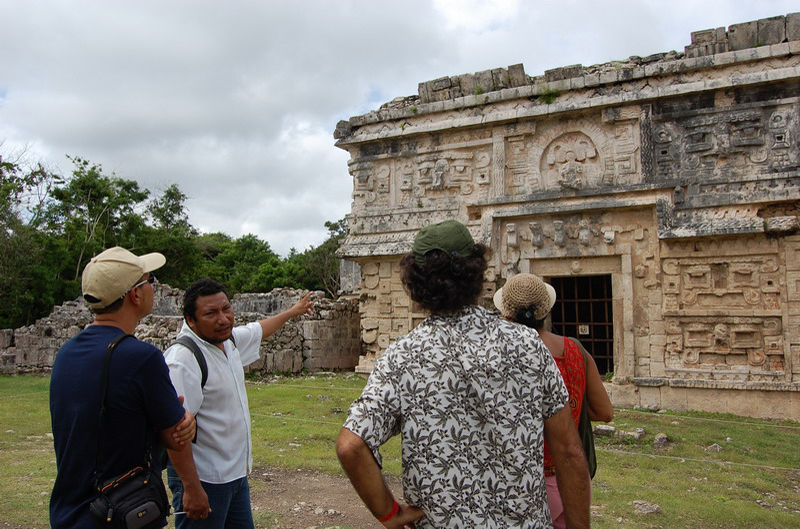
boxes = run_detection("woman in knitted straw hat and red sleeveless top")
[494,274,614,529]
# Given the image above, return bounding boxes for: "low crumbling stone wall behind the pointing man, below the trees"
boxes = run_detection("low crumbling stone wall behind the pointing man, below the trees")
[0,284,361,375]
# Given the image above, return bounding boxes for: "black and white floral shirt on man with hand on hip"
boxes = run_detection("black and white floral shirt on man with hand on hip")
[344,306,568,528]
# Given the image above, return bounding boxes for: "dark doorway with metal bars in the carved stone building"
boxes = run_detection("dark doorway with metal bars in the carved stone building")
[550,275,614,375]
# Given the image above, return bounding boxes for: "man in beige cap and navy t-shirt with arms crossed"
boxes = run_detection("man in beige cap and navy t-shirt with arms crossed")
[50,247,195,528]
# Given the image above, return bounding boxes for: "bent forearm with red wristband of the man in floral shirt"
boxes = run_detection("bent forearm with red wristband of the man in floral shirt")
[336,428,425,527]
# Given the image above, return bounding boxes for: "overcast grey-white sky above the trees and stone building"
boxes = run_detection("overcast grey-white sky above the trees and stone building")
[0,0,800,256]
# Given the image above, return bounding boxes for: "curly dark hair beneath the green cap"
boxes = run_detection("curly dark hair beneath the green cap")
[400,244,488,314]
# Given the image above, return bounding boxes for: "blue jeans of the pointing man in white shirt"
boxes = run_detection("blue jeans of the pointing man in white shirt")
[167,464,255,529]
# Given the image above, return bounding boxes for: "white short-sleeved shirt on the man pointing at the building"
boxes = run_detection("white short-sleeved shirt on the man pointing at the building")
[165,322,262,484]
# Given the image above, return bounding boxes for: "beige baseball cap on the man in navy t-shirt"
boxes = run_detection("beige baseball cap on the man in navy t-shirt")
[81,246,167,309]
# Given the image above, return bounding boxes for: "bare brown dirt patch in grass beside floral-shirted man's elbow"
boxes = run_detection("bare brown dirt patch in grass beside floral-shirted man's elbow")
[250,468,402,529]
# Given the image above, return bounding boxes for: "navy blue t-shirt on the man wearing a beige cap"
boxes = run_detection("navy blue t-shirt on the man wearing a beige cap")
[50,325,184,529]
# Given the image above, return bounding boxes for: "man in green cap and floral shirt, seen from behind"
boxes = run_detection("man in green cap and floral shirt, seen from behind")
[337,220,589,529]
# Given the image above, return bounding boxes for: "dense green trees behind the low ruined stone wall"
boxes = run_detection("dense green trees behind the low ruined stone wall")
[0,151,346,328]
